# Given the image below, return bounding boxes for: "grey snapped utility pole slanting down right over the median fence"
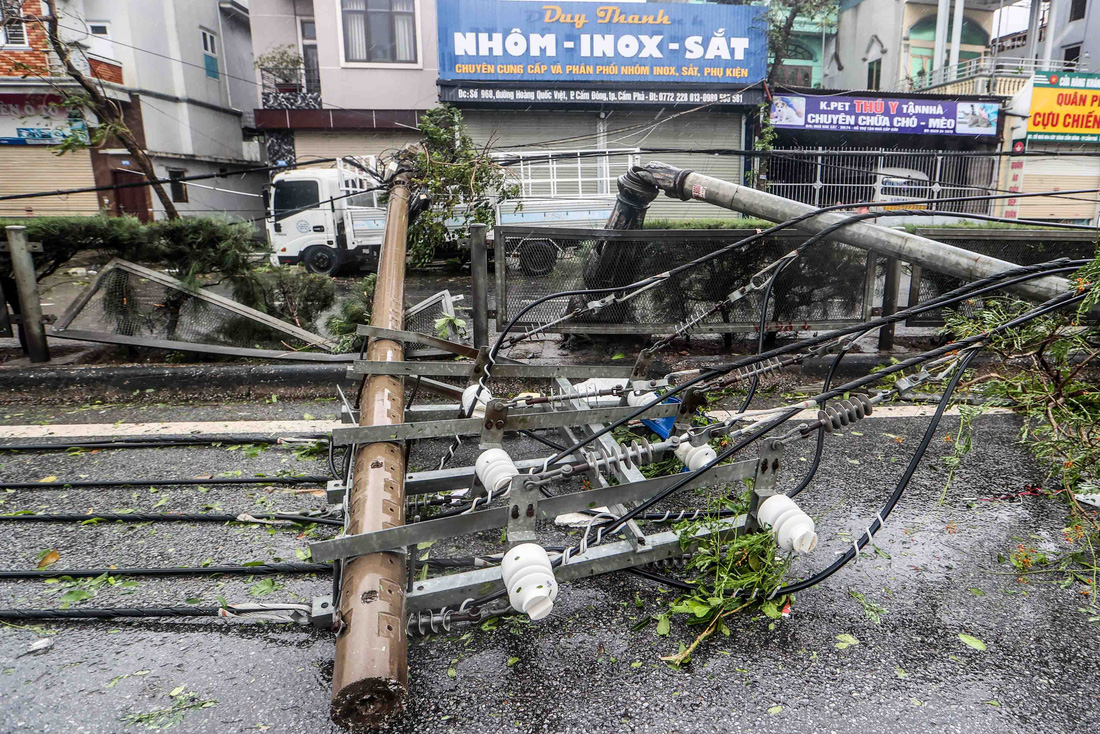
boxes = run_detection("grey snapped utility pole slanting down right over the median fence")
[611,161,1071,300]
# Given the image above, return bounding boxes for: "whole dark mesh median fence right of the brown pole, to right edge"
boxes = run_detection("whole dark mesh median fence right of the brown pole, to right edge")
[494,227,1097,335]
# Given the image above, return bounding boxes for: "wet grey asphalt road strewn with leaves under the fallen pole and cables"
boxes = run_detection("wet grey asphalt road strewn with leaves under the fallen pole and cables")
[0,402,1100,734]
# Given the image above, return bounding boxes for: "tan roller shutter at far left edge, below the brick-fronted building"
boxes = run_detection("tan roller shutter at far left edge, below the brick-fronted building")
[0,145,99,217]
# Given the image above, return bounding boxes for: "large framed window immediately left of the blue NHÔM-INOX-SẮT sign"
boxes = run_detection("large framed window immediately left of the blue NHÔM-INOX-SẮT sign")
[340,0,417,64]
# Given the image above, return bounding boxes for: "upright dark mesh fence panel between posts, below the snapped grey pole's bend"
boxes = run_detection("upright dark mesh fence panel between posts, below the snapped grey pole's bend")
[496,228,868,333]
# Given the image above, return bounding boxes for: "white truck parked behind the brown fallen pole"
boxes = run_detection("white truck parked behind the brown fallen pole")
[266,153,615,275]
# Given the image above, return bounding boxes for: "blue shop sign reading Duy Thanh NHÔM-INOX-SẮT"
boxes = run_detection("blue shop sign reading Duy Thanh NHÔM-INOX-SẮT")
[437,0,768,86]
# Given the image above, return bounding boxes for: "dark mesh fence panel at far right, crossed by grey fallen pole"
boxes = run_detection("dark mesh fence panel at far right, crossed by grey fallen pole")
[906,228,1097,326]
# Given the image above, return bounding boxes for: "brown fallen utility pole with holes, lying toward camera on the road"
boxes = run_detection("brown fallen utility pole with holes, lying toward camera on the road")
[330,174,410,730]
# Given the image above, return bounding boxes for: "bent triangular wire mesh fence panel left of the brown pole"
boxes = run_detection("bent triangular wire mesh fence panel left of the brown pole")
[58,267,321,350]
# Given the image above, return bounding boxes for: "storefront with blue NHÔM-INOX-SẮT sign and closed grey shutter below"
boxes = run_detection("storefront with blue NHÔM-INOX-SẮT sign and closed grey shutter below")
[437,0,767,219]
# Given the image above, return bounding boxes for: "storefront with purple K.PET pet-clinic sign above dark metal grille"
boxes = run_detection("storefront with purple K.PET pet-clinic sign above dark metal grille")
[767,90,1003,213]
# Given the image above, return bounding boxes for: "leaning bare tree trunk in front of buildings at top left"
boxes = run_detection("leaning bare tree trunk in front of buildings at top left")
[3,0,179,219]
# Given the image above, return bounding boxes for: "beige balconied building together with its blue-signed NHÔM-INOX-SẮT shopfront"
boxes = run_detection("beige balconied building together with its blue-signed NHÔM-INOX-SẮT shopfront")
[253,0,774,218]
